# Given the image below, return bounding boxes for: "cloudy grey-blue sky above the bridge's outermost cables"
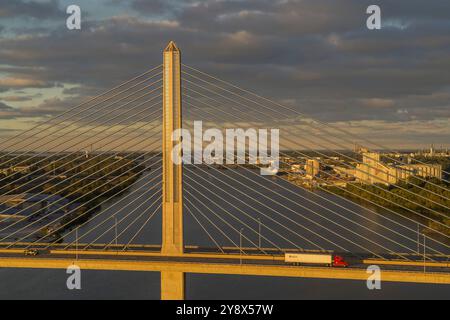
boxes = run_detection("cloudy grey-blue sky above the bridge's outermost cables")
[0,0,450,148]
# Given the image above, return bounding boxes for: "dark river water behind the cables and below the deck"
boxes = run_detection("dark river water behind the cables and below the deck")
[0,158,450,299]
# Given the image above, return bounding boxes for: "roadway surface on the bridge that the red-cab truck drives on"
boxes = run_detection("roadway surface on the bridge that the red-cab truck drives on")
[0,244,450,274]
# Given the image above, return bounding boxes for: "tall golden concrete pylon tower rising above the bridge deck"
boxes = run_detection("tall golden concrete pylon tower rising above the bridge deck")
[161,41,184,255]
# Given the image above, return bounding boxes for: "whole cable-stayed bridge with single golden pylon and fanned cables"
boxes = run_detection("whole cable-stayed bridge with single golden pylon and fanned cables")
[0,42,450,299]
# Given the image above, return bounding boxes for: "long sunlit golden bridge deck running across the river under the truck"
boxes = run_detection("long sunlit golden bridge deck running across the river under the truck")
[0,249,450,284]
